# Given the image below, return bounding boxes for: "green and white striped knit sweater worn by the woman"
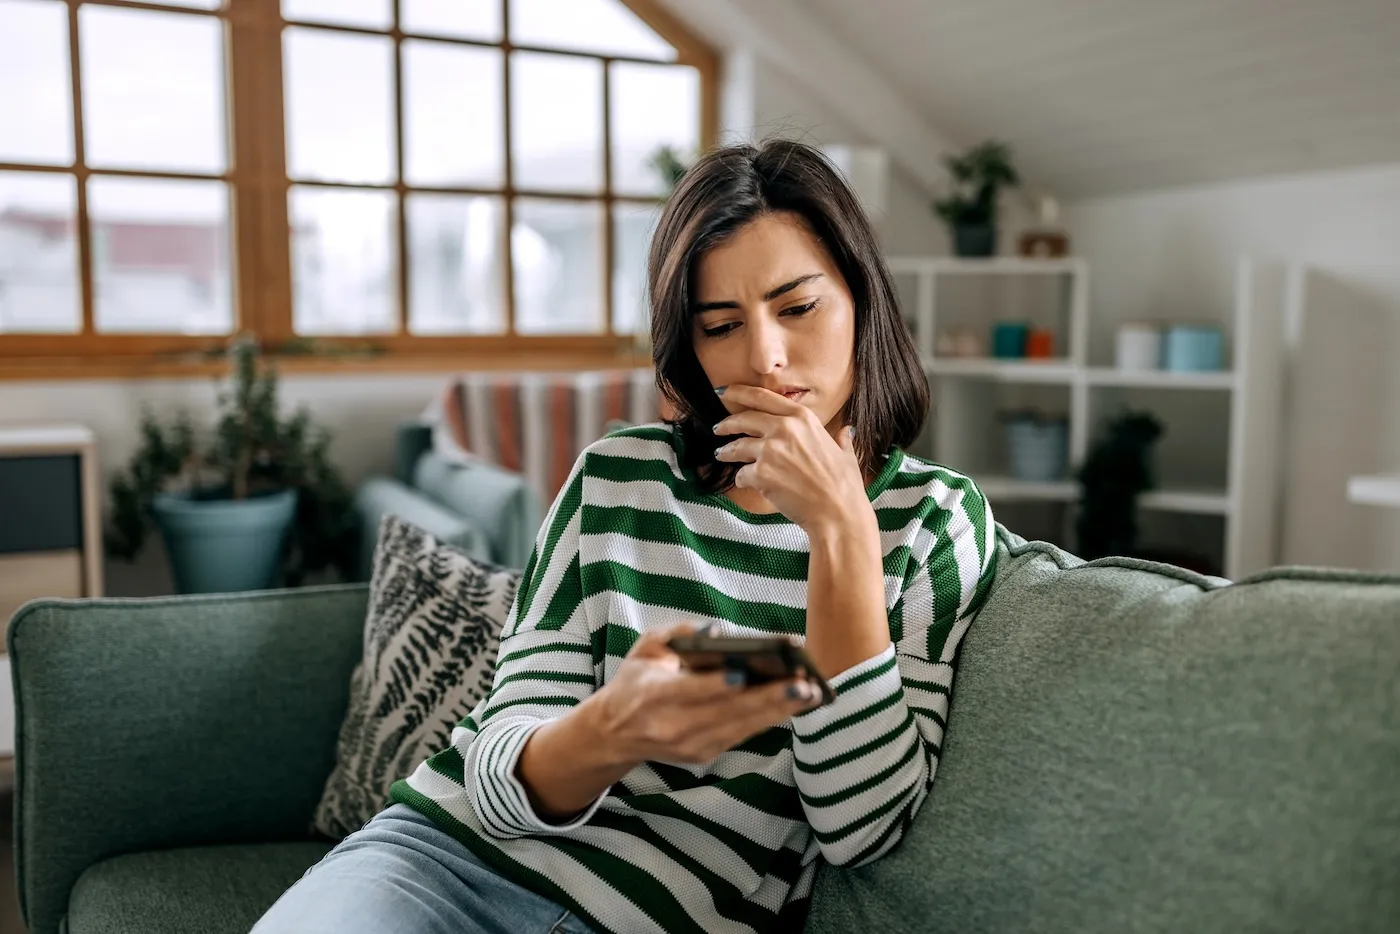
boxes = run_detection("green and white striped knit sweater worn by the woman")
[392,426,994,934]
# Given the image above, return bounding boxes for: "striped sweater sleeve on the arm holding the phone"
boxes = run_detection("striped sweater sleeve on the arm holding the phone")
[454,454,608,839]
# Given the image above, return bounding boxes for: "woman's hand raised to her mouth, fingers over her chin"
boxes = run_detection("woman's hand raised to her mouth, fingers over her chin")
[714,385,872,535]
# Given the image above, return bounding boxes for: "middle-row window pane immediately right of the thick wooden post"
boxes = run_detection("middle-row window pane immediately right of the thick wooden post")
[283,28,398,185]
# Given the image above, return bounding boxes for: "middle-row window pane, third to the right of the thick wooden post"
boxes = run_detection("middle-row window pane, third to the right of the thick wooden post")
[511,52,603,192]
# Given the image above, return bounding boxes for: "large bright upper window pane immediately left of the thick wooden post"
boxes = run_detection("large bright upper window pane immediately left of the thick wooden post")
[78,6,228,172]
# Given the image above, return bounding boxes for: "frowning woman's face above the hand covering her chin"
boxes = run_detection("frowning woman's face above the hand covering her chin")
[692,211,855,434]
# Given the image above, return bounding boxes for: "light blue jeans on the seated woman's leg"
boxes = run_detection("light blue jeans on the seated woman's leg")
[253,804,594,934]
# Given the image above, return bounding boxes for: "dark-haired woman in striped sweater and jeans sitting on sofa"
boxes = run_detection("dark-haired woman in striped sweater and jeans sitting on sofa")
[256,141,993,934]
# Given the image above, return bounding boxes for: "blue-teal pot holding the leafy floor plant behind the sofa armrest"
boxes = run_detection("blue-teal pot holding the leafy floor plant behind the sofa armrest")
[151,490,297,594]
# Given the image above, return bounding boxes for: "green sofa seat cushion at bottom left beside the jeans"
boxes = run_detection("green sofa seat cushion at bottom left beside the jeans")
[67,843,330,934]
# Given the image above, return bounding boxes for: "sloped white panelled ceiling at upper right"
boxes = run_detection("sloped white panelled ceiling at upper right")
[795,0,1400,197]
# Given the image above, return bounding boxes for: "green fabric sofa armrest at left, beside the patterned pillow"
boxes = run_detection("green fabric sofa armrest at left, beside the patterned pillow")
[8,585,368,934]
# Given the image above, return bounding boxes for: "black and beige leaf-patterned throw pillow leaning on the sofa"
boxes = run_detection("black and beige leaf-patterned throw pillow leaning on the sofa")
[314,515,519,840]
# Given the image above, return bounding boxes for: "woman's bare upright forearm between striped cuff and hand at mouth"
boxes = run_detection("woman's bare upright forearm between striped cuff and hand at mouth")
[806,507,889,678]
